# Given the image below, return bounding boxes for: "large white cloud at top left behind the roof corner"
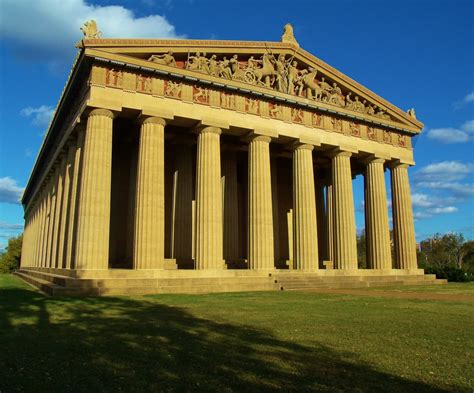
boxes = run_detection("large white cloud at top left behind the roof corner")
[0,0,182,63]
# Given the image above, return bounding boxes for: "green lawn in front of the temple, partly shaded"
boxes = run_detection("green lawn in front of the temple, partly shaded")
[0,275,474,393]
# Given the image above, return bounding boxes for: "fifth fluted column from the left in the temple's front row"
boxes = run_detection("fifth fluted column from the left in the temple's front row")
[293,144,319,270]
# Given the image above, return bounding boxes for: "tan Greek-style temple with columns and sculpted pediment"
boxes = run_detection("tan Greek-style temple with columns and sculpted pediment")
[17,21,440,295]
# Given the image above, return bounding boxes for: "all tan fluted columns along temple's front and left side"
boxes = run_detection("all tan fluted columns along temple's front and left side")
[21,109,416,270]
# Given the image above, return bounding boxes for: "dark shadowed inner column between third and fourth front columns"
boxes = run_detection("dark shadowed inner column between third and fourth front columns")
[222,151,239,262]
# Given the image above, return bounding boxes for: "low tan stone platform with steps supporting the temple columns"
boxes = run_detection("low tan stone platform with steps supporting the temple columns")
[16,268,446,296]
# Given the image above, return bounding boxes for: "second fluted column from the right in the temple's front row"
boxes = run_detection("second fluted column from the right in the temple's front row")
[365,159,392,269]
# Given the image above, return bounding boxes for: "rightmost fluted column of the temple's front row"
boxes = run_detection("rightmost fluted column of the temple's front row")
[391,163,417,269]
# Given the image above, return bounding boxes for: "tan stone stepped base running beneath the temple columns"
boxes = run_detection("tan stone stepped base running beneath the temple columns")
[13,269,446,296]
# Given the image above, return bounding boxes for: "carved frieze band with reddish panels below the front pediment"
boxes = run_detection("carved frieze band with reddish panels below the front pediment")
[92,67,410,148]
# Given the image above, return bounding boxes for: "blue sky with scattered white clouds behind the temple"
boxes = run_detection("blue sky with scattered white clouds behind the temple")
[0,0,474,249]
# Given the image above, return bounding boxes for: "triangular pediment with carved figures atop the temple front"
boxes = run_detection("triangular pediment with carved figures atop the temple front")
[82,39,423,133]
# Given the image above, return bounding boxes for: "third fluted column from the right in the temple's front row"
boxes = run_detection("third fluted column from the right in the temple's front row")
[332,151,357,270]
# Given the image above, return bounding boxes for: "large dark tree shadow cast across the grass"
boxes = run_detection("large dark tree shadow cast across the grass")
[0,288,450,393]
